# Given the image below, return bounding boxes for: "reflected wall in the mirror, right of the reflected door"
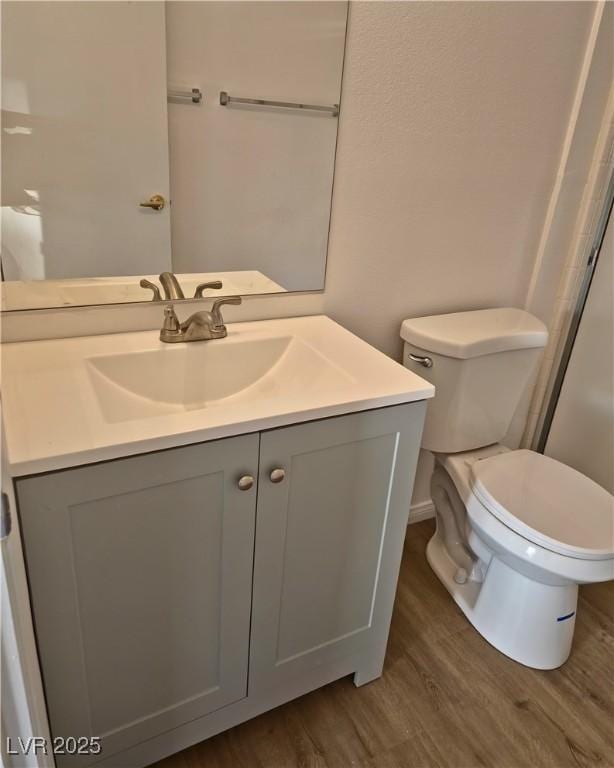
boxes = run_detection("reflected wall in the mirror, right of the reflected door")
[166,2,346,290]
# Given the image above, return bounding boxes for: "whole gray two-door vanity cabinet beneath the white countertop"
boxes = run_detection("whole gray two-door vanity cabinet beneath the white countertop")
[17,403,425,768]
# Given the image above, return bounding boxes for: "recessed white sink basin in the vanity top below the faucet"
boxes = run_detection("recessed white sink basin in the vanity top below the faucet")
[86,333,352,422]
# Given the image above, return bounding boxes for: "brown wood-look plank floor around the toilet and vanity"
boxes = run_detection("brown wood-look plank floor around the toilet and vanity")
[156,520,614,768]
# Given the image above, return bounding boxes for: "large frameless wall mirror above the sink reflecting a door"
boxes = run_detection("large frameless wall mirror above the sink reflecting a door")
[0,0,347,310]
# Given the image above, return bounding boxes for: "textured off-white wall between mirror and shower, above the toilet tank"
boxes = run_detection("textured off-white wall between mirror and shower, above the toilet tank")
[325,2,593,358]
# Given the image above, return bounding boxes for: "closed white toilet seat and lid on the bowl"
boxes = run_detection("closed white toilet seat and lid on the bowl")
[471,450,614,560]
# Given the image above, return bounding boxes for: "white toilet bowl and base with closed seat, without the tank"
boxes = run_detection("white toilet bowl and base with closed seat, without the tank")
[427,446,614,669]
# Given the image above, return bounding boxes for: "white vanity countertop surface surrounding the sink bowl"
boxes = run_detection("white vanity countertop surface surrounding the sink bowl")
[2,315,435,476]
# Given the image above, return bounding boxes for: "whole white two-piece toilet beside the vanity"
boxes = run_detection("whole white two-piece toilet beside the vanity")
[401,309,614,669]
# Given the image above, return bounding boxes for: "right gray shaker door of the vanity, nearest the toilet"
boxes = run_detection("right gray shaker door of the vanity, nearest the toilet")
[250,403,424,694]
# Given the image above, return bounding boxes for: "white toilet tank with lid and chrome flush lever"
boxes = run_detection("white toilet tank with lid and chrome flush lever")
[401,308,548,453]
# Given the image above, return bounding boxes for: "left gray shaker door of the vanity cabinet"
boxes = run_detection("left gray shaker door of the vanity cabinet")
[18,435,259,765]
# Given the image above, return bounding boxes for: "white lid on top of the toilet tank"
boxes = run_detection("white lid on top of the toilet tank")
[401,307,548,359]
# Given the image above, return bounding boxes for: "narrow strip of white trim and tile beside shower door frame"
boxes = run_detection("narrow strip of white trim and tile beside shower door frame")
[523,2,614,446]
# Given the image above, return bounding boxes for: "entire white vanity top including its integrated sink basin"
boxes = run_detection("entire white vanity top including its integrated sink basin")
[2,315,434,477]
